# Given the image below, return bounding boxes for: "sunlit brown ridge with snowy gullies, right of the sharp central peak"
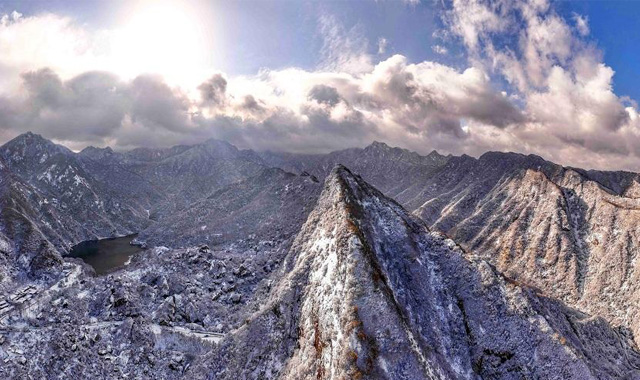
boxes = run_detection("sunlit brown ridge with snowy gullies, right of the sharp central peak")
[400,153,640,348]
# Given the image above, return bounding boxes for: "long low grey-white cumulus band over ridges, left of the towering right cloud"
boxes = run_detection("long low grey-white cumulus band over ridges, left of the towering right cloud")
[0,51,524,152]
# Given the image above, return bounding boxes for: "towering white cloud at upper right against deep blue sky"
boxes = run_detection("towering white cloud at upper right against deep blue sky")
[444,0,640,169]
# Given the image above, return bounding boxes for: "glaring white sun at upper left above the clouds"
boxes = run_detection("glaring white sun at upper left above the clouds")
[112,1,209,85]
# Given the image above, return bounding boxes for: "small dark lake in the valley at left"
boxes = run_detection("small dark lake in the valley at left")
[69,234,142,275]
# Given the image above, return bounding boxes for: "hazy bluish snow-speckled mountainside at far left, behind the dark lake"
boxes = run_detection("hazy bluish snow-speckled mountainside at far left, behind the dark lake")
[0,132,266,283]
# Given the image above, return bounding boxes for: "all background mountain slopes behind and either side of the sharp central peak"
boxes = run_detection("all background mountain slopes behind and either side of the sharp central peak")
[7,133,640,360]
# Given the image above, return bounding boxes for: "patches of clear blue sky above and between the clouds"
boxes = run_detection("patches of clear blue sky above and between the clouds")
[0,0,640,89]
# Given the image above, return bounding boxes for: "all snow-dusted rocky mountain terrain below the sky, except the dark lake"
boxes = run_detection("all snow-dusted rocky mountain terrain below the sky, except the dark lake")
[0,133,640,379]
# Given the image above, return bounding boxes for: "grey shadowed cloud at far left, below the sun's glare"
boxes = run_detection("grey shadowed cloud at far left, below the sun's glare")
[0,69,200,145]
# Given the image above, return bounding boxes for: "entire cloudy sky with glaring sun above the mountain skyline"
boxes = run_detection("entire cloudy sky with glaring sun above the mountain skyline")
[0,0,640,170]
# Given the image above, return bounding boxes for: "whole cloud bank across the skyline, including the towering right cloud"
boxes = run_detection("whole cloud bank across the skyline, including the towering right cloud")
[0,0,640,170]
